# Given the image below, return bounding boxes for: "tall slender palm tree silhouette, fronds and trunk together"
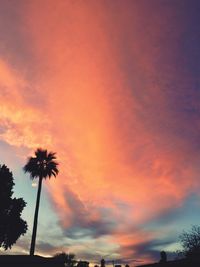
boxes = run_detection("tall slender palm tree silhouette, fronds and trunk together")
[23,148,58,256]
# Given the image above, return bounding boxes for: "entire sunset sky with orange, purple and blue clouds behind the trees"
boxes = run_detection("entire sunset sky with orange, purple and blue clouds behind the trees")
[0,0,200,265]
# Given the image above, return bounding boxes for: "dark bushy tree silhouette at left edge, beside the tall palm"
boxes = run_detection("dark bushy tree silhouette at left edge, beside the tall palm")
[0,165,27,250]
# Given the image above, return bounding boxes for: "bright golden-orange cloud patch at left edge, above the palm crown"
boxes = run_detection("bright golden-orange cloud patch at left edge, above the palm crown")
[0,59,50,147]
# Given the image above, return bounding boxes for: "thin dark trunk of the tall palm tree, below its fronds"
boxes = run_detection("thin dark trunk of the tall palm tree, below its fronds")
[30,177,42,256]
